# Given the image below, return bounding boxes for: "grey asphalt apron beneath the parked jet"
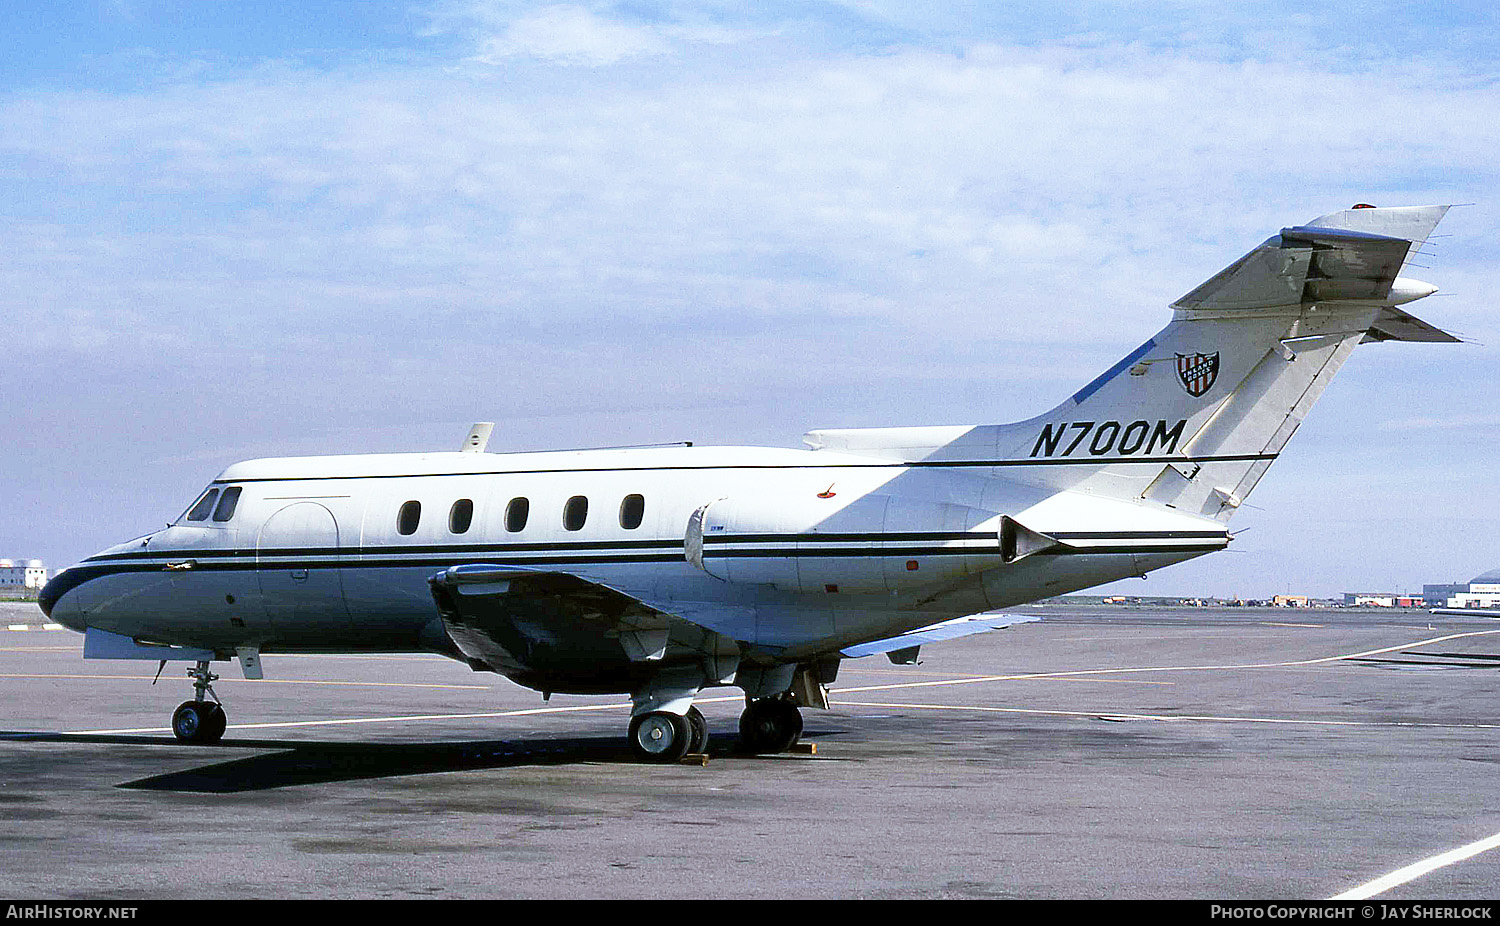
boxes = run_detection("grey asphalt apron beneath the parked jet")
[0,605,1500,900]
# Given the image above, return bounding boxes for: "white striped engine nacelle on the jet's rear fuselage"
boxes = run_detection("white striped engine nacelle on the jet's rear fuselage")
[686,495,1016,593]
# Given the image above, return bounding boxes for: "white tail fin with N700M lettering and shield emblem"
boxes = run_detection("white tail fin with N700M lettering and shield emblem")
[807,206,1458,521]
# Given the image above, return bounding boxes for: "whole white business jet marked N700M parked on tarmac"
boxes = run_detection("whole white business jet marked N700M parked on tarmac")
[41,206,1457,761]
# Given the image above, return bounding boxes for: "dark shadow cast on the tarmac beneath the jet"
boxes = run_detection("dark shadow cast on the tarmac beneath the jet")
[0,731,792,794]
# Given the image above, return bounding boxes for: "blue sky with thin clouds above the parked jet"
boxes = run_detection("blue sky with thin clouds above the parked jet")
[0,2,1500,596]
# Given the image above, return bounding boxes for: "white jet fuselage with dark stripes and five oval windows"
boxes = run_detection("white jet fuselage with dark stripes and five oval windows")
[45,447,1227,690]
